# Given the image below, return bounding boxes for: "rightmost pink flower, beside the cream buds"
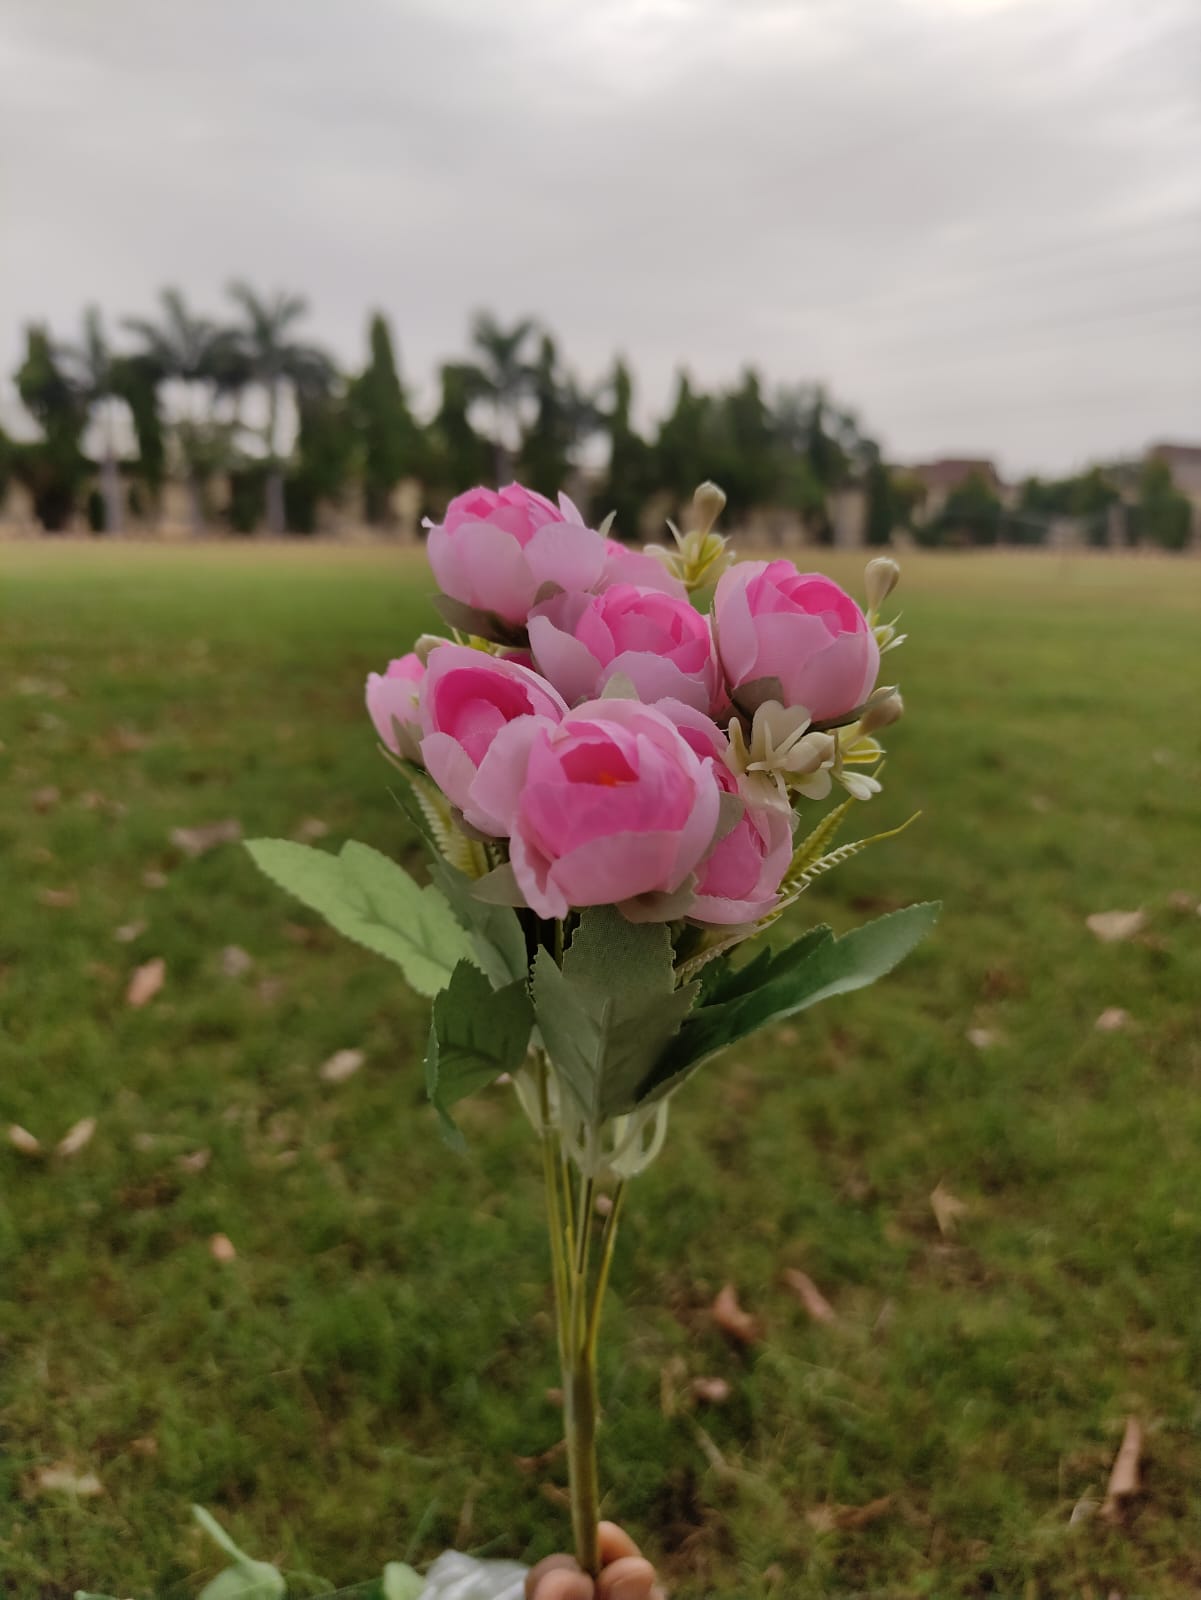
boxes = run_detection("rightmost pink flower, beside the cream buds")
[713,562,880,722]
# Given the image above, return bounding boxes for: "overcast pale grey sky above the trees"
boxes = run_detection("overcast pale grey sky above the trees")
[0,0,1201,475]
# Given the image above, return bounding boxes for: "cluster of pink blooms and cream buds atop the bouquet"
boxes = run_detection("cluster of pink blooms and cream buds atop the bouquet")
[366,483,900,928]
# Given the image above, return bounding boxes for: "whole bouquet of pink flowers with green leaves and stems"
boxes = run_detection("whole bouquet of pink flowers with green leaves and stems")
[248,483,937,1574]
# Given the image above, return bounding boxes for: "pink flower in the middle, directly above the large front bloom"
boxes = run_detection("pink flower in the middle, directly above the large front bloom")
[529,584,720,710]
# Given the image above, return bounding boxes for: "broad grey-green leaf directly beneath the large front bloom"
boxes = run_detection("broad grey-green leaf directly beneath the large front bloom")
[534,906,697,1126]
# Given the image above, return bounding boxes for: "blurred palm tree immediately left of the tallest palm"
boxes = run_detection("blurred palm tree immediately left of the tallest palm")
[125,290,230,534]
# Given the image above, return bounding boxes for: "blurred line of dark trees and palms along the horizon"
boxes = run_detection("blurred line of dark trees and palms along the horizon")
[0,291,1187,544]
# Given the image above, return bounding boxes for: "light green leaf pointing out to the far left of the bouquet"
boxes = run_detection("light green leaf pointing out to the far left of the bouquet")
[246,838,472,995]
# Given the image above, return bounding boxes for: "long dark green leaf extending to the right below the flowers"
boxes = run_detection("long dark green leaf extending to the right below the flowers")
[638,902,940,1099]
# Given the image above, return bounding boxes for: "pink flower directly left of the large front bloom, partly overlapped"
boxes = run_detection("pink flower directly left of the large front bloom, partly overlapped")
[419,645,568,832]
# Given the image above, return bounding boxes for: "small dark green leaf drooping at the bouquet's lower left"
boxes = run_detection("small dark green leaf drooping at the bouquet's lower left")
[425,962,534,1147]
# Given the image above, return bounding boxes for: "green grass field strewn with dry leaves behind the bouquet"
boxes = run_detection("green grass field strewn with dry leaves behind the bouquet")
[0,544,1201,1600]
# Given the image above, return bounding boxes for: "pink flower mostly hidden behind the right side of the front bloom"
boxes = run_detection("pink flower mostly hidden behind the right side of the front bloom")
[659,701,793,923]
